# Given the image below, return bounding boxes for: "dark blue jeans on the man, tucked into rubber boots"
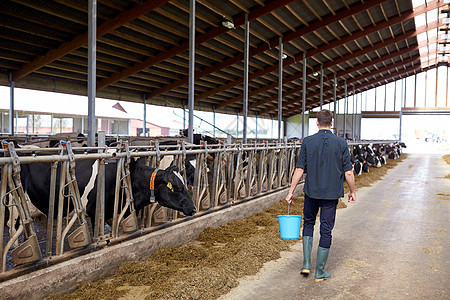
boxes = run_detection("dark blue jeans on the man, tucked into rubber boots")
[303,194,339,248]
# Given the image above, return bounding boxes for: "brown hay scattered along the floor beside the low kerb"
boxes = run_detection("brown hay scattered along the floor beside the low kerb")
[48,154,406,300]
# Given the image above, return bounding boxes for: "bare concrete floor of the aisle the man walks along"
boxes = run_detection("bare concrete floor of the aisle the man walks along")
[220,154,450,300]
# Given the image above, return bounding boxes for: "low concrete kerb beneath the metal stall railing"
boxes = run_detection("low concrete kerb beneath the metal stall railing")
[0,185,303,300]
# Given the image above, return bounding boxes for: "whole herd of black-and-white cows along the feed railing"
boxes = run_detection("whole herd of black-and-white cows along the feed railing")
[0,135,406,274]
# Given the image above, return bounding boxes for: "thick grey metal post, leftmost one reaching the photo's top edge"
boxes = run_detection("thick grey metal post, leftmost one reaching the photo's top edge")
[88,0,97,147]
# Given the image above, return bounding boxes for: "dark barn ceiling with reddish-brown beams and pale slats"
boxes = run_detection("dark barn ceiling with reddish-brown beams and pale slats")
[0,0,450,117]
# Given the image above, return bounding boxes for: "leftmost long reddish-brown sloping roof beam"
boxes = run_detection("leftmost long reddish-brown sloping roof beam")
[12,0,169,81]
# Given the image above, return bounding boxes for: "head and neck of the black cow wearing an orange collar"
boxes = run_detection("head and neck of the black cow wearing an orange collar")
[130,160,196,216]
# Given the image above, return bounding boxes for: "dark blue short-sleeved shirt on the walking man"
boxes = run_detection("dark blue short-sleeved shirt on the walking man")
[296,129,352,200]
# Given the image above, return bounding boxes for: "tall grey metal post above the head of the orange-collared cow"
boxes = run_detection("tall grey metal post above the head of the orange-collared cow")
[188,0,195,143]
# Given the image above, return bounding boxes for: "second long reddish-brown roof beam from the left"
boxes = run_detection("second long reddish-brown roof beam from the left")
[97,0,294,89]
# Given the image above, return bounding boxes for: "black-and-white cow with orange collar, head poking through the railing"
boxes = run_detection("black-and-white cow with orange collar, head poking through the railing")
[21,159,196,229]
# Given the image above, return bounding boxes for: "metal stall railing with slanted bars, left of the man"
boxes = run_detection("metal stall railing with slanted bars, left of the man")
[0,141,300,278]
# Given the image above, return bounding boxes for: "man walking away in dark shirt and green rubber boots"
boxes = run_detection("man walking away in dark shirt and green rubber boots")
[286,109,356,282]
